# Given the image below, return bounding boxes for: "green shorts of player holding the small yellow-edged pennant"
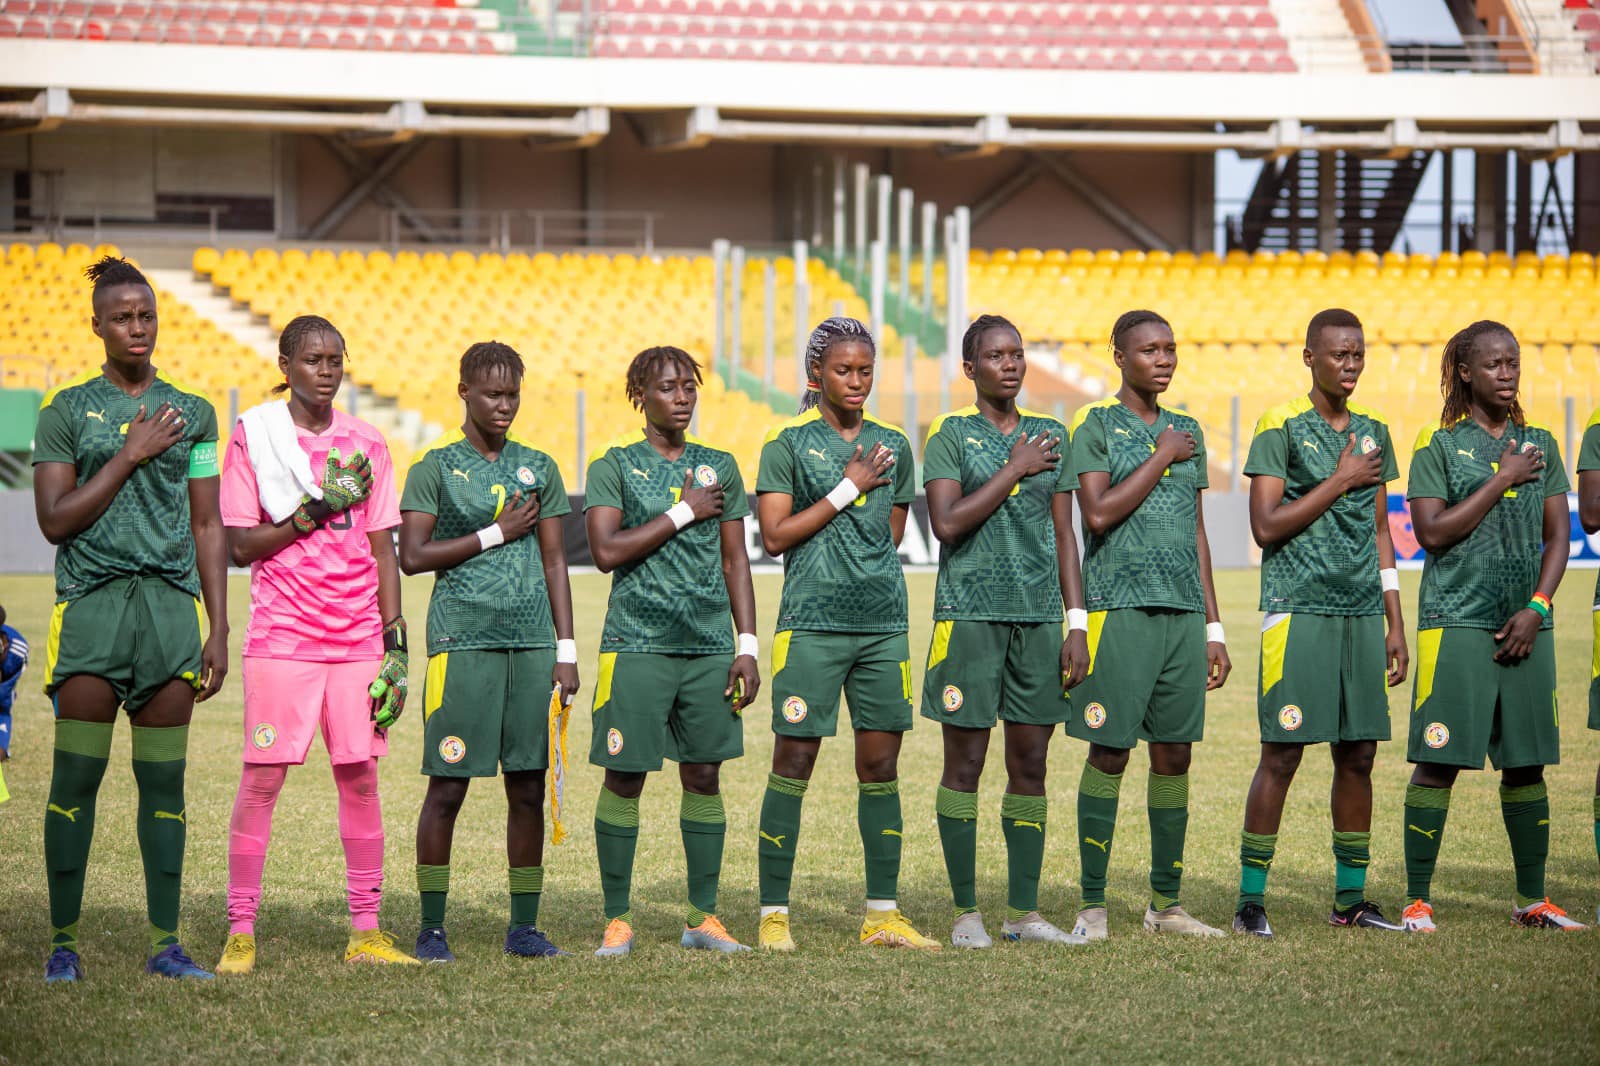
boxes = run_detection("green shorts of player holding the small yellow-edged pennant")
[422,648,555,778]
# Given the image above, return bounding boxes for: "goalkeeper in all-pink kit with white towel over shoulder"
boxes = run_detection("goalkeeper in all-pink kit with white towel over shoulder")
[216,315,416,973]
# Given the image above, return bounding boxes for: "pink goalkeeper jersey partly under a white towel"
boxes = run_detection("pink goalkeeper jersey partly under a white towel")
[221,410,400,663]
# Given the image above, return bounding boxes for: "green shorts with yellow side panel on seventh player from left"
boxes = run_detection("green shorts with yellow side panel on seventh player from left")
[1067,607,1206,749]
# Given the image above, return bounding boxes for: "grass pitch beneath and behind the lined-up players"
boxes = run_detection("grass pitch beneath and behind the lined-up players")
[0,571,1600,1063]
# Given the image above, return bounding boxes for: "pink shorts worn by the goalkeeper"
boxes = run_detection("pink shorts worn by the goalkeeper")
[245,656,389,767]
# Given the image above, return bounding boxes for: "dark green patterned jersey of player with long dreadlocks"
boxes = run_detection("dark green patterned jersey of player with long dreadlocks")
[1406,418,1568,631]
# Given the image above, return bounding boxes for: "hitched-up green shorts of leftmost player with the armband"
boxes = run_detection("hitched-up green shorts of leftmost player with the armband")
[45,576,205,714]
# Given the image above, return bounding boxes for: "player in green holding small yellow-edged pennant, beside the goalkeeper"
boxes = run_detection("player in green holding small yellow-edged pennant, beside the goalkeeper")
[400,341,578,962]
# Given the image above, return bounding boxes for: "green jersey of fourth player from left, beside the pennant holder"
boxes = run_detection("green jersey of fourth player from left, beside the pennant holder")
[584,431,750,655]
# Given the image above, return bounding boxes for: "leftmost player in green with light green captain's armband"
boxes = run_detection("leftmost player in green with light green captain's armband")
[34,256,227,983]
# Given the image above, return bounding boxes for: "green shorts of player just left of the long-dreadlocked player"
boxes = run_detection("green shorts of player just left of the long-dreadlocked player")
[1256,615,1389,744]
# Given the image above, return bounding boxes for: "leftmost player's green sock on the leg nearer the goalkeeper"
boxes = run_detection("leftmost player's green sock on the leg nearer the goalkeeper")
[133,725,189,954]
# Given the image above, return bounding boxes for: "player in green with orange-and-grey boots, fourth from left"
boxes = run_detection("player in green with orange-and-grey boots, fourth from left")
[584,347,760,957]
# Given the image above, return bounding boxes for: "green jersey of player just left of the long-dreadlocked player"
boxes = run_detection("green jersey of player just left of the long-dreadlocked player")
[1245,397,1400,615]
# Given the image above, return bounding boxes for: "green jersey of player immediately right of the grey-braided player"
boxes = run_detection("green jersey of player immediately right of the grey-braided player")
[922,407,1078,623]
